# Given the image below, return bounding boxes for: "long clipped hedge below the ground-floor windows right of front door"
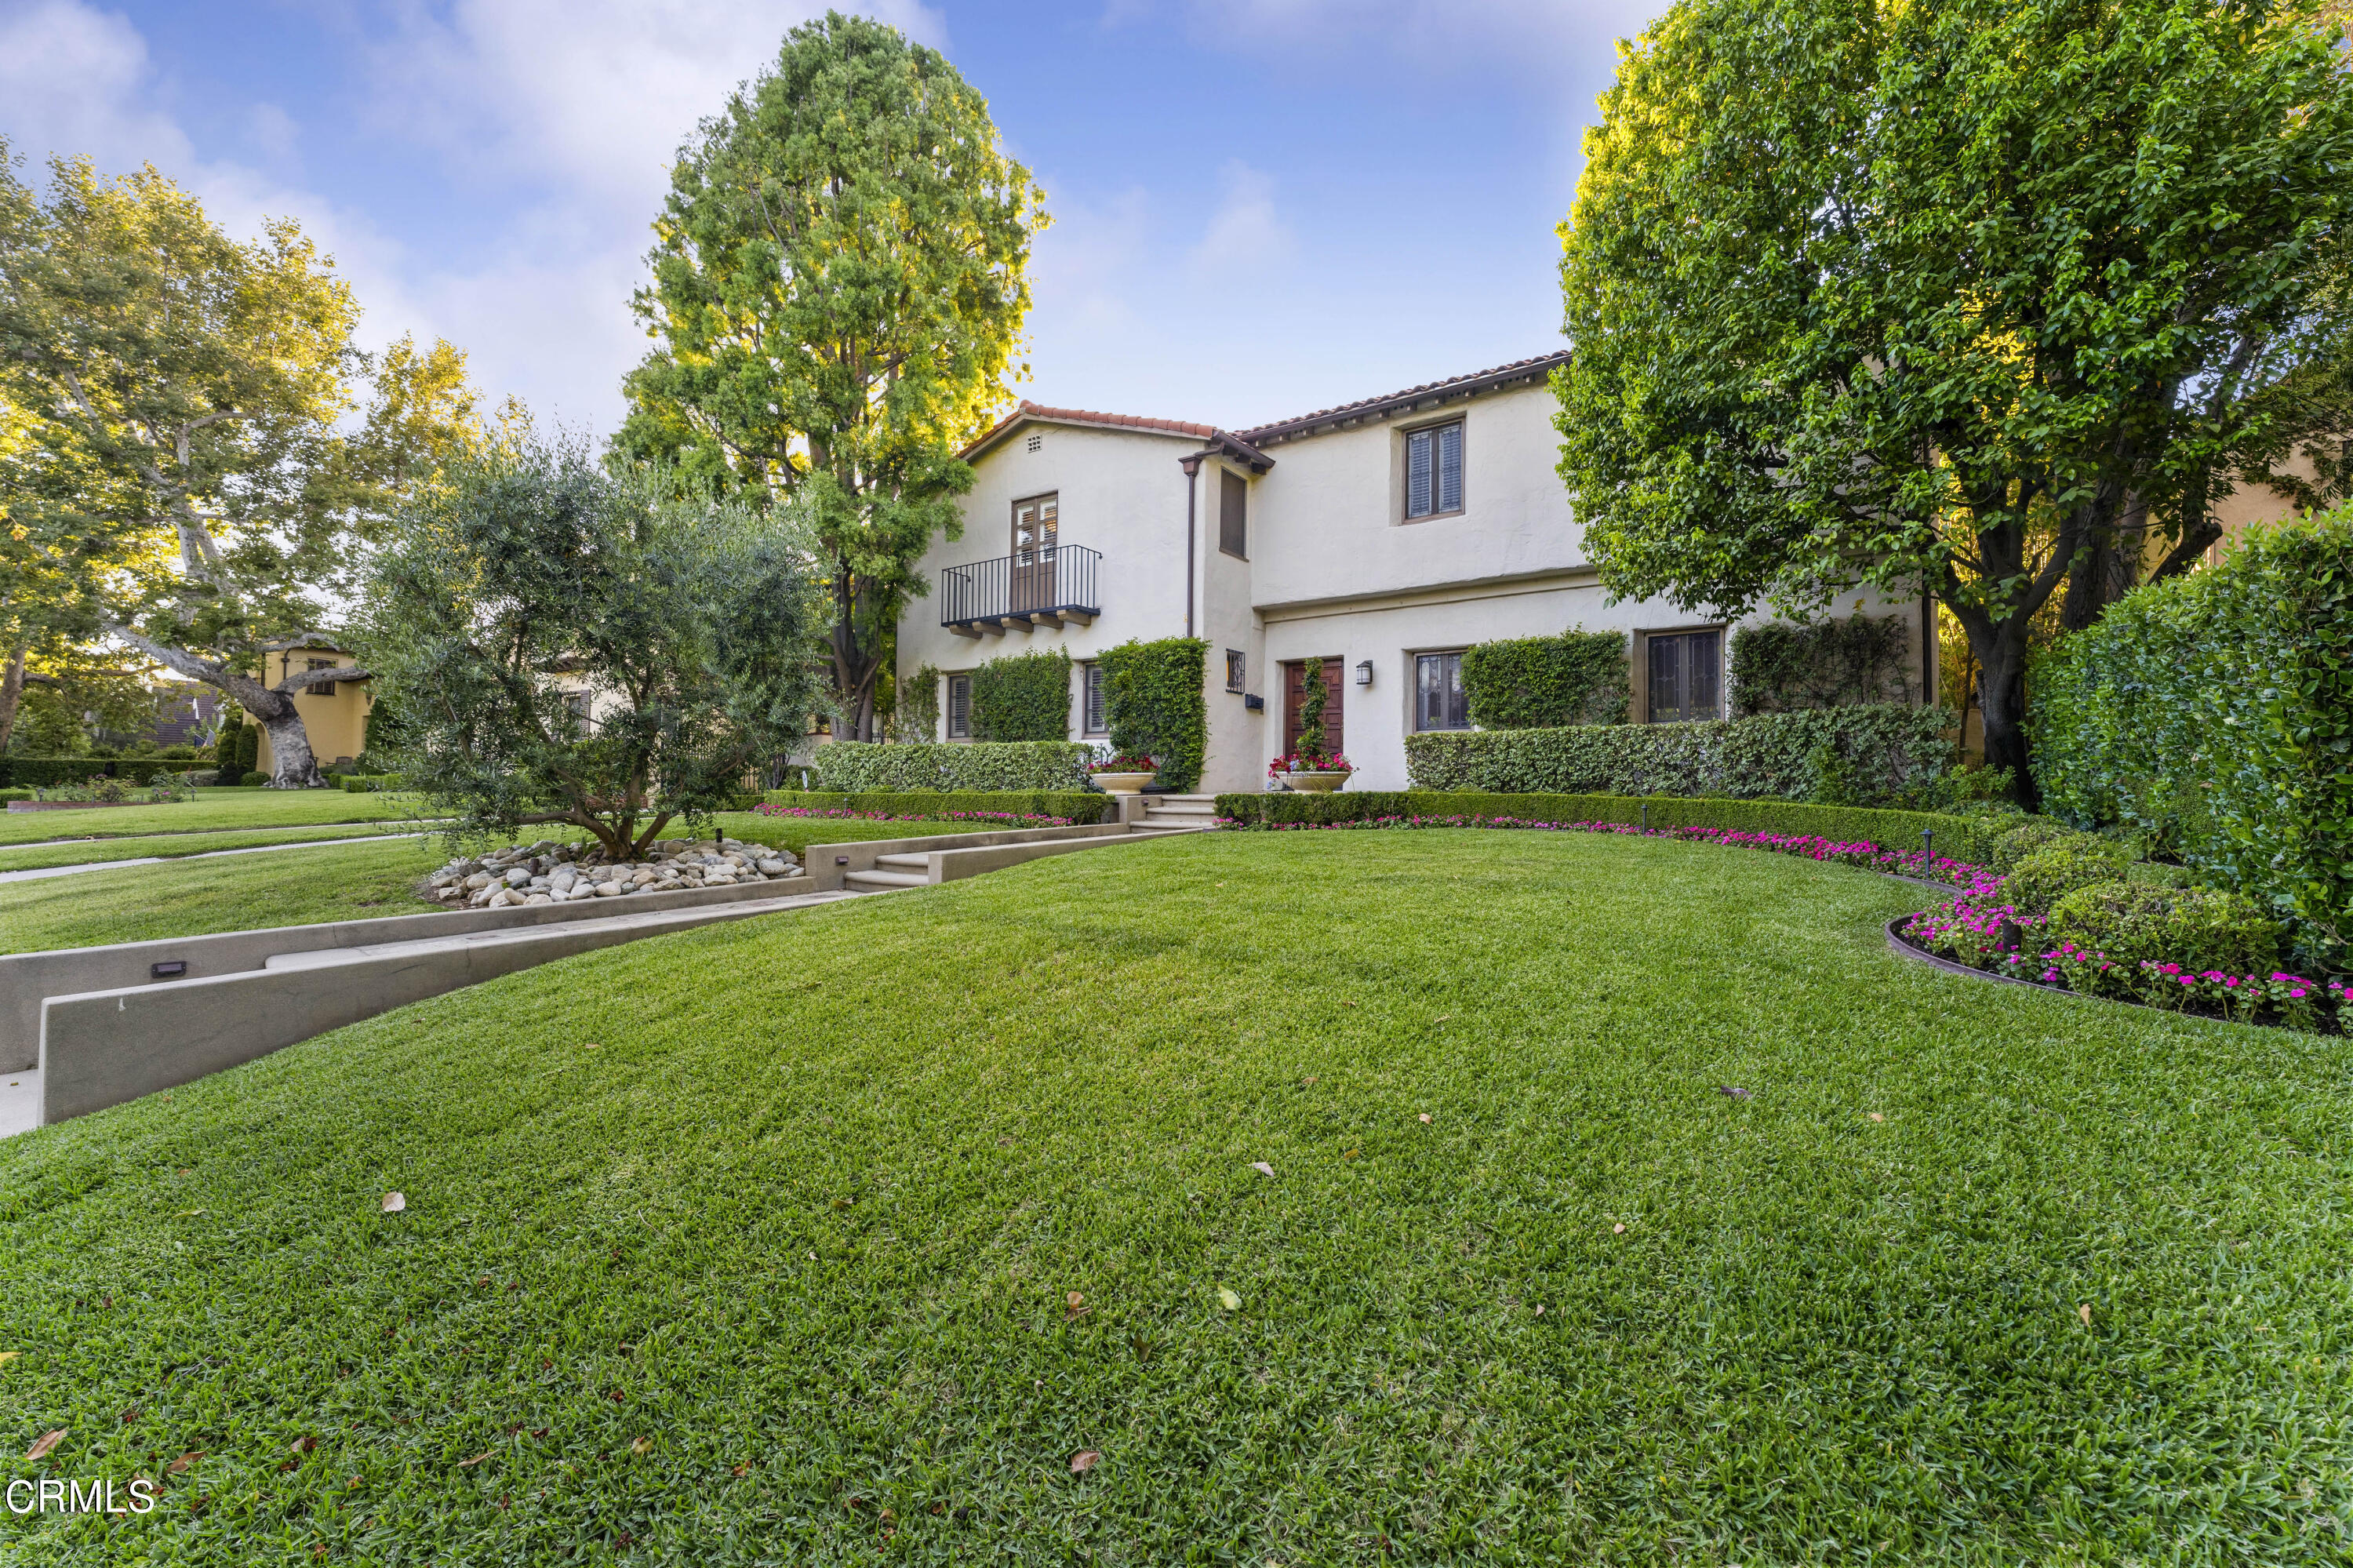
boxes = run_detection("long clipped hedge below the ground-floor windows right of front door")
[1405,706,1958,801]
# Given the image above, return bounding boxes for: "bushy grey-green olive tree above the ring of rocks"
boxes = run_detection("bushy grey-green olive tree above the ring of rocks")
[358,428,821,860]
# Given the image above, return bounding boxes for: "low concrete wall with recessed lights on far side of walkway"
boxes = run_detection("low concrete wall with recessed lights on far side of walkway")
[0,876,809,1074]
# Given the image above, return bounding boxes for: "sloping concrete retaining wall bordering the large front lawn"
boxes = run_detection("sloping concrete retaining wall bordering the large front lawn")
[40,879,840,1126]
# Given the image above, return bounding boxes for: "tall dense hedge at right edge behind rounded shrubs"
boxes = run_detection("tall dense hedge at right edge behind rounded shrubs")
[2028,508,2353,968]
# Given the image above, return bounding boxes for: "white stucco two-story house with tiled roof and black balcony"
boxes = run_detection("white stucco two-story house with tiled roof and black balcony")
[899,353,1937,794]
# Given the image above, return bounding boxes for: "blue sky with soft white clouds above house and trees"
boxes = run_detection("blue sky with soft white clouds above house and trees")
[0,0,1659,433]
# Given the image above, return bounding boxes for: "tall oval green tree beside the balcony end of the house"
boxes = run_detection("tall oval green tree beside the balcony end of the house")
[614,12,1045,739]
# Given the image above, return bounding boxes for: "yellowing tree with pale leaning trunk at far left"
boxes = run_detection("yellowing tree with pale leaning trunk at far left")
[0,148,475,787]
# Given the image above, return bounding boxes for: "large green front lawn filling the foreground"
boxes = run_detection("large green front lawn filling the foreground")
[0,831,2353,1566]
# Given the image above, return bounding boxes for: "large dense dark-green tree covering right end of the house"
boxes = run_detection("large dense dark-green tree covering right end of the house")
[1555,0,2353,799]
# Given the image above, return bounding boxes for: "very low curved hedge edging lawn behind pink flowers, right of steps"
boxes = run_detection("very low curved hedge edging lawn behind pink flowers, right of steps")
[1217,789,2009,864]
